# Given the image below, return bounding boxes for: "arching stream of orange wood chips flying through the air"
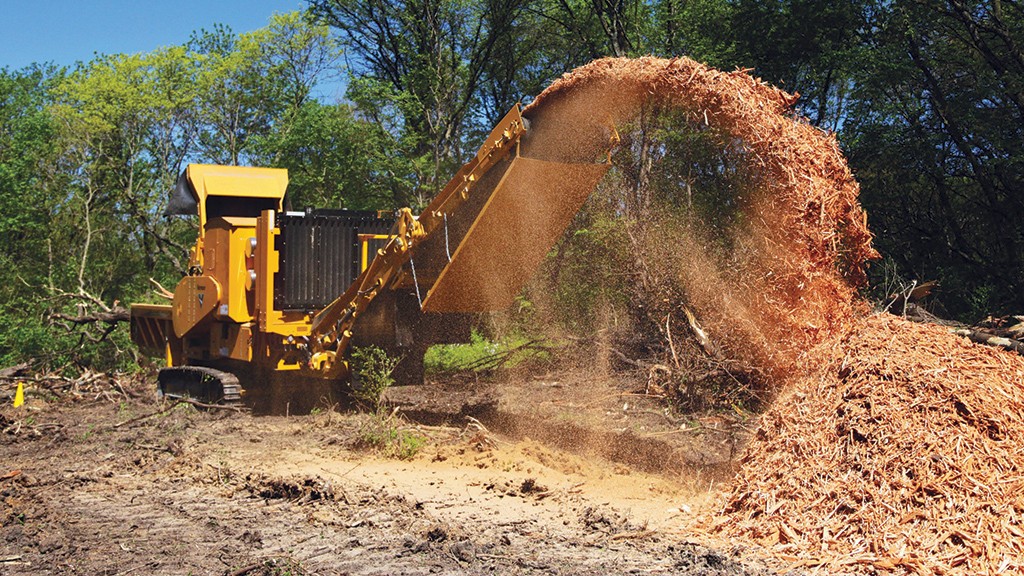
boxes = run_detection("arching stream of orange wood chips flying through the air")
[522,57,877,376]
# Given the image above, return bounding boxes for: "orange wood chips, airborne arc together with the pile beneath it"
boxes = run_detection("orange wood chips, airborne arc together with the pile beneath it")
[523,58,1024,574]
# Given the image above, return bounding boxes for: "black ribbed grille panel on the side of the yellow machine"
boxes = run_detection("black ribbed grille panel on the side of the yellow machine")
[273,210,394,311]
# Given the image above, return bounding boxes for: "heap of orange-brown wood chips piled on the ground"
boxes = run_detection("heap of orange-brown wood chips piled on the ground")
[714,315,1024,574]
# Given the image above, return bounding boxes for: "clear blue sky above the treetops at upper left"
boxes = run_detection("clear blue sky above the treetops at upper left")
[0,0,306,70]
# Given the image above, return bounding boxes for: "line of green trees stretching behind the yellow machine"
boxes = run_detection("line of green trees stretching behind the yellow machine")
[0,0,1024,373]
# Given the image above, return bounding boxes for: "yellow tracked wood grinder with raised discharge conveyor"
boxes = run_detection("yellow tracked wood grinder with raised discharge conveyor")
[131,106,610,403]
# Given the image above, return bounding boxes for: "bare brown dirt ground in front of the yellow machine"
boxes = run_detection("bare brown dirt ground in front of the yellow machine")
[0,371,777,575]
